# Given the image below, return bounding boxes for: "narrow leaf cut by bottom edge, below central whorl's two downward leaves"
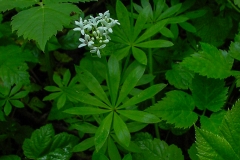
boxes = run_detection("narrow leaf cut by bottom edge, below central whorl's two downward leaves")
[108,137,121,160]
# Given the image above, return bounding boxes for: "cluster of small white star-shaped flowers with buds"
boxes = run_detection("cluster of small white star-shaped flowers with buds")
[73,11,120,58]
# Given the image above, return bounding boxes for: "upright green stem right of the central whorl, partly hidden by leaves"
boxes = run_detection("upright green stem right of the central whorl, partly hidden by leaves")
[148,39,160,139]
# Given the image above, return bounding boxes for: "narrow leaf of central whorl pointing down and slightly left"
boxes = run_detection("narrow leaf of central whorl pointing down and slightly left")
[94,112,113,152]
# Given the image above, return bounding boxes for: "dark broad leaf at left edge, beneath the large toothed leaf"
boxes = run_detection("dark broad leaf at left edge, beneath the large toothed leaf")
[0,45,38,86]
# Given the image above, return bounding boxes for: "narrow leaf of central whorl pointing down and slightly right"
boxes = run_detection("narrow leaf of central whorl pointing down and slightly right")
[113,113,131,147]
